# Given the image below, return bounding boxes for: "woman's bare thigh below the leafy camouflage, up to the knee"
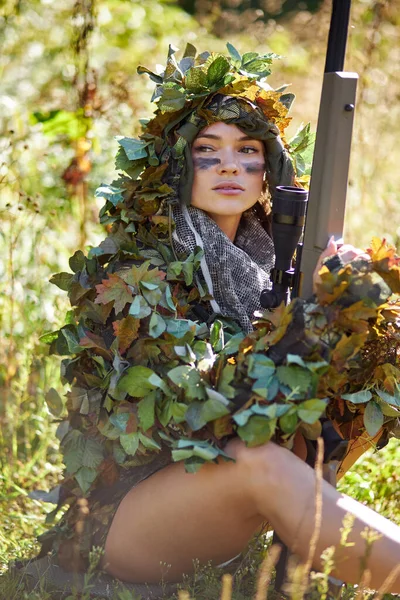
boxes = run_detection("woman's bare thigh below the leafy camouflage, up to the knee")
[104,440,263,583]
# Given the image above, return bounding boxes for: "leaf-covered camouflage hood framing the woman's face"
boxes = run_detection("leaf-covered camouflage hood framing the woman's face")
[108,44,298,221]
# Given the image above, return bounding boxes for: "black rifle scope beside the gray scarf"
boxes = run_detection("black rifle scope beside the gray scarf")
[260,185,308,308]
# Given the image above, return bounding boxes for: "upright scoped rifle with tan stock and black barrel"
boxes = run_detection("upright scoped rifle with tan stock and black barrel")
[261,0,358,591]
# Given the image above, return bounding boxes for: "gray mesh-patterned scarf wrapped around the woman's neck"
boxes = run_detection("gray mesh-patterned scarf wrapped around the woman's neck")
[173,205,275,333]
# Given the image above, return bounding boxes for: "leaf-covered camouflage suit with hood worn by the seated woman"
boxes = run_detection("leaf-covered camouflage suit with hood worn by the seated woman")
[36,45,400,570]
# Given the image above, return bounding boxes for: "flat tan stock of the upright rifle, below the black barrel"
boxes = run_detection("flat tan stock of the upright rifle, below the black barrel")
[300,71,358,298]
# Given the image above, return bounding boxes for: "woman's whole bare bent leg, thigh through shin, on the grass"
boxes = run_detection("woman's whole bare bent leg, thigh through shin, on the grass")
[105,440,400,592]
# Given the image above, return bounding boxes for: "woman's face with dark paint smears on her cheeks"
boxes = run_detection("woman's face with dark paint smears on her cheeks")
[191,122,265,217]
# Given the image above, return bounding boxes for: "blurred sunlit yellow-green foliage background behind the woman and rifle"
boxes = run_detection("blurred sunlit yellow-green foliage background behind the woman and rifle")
[0,0,400,592]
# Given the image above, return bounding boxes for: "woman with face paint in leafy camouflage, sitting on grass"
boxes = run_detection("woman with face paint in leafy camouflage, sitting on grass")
[44,47,400,591]
